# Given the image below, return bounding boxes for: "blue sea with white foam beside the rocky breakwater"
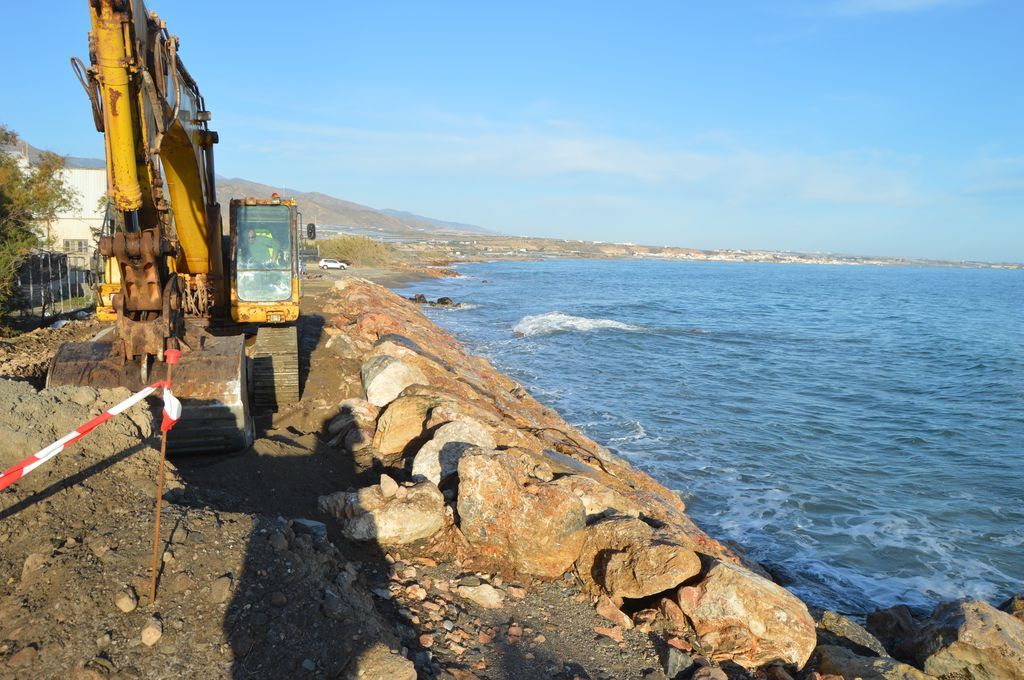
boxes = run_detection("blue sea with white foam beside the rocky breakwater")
[400,260,1024,614]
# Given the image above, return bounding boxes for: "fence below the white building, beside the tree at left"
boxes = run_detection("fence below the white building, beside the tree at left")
[11,251,96,323]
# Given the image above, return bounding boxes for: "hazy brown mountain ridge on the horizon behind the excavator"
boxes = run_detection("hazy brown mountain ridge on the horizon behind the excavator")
[12,141,494,238]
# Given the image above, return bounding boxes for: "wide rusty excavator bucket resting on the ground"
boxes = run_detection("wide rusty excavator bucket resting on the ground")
[46,335,254,453]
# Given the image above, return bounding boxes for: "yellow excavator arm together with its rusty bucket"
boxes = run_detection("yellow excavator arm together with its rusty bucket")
[47,0,253,451]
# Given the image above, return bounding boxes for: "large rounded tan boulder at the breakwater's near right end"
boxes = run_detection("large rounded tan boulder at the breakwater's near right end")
[678,561,817,669]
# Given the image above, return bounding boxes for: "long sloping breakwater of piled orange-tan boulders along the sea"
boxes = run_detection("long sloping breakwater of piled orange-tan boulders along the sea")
[319,279,817,677]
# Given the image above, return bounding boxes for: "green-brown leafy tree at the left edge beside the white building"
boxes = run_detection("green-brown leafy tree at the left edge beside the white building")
[0,124,78,314]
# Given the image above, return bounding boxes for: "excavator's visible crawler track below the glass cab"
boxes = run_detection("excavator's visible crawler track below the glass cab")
[253,326,299,411]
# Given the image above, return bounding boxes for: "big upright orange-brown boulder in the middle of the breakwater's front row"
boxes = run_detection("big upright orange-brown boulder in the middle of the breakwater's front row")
[458,451,586,579]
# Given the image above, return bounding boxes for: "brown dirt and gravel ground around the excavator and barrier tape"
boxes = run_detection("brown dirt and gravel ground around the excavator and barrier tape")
[0,270,688,680]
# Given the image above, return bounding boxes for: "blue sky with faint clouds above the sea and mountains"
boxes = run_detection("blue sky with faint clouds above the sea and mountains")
[0,0,1024,261]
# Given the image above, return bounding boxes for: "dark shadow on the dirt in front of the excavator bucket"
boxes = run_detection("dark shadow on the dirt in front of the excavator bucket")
[175,401,411,678]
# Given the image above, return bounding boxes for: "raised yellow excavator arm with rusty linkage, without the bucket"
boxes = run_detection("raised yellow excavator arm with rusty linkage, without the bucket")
[73,0,227,358]
